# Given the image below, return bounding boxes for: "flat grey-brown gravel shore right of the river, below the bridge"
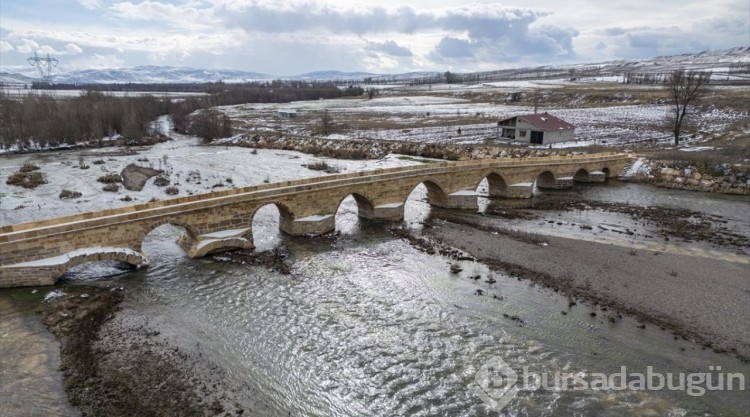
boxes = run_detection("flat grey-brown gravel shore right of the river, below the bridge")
[425,221,750,361]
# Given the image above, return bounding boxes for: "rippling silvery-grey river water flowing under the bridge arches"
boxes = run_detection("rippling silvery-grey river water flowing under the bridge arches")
[0,184,750,416]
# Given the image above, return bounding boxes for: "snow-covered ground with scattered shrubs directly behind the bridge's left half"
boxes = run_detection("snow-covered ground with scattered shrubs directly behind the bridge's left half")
[0,120,416,225]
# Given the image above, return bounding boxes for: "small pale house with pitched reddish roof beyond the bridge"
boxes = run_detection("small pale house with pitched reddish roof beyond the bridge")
[497,113,575,145]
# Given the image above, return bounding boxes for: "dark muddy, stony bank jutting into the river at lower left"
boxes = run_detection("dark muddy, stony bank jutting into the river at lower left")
[42,286,249,416]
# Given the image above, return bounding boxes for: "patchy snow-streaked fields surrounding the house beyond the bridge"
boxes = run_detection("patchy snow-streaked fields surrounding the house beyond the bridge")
[220,80,748,147]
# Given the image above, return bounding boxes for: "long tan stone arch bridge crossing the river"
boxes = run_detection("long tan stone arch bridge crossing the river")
[0,153,628,287]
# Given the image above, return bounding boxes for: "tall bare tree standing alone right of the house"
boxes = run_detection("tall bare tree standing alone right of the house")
[667,69,711,146]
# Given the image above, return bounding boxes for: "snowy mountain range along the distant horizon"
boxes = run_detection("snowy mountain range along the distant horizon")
[0,46,750,84]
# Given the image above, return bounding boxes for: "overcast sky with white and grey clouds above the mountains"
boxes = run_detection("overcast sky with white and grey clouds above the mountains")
[0,0,750,75]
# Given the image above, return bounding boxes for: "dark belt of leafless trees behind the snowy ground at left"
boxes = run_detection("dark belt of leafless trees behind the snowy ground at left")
[0,81,364,150]
